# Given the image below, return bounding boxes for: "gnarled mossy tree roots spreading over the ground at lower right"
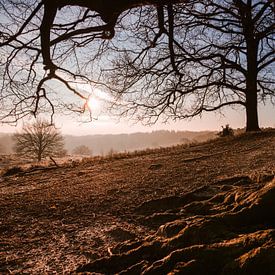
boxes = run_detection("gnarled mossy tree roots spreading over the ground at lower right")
[77,175,275,275]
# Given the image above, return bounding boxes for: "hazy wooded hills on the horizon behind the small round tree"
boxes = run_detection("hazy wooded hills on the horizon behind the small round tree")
[0,130,216,155]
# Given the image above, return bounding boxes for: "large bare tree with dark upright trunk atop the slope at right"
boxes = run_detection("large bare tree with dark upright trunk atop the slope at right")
[106,0,275,131]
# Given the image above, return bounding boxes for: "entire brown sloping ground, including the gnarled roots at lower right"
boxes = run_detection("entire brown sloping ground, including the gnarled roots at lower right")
[0,131,275,274]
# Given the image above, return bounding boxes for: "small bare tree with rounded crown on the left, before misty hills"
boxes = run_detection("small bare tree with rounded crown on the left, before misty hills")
[13,120,65,161]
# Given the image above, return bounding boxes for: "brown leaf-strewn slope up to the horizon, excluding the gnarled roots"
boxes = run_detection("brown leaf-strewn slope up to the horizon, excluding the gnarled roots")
[0,131,275,274]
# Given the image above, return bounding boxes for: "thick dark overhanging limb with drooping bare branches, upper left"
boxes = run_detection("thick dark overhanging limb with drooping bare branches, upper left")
[0,0,179,123]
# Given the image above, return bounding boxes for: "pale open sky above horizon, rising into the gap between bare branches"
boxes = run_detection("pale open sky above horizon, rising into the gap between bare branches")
[0,77,275,135]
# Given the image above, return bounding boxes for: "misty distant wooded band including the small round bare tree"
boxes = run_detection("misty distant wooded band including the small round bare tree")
[0,120,220,161]
